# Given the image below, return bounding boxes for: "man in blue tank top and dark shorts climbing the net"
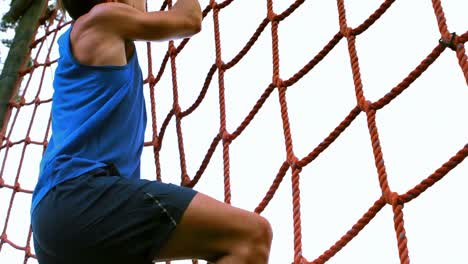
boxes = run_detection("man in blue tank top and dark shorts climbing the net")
[31,0,272,264]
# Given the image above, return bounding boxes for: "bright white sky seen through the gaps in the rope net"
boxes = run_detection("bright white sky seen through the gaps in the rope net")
[0,0,468,264]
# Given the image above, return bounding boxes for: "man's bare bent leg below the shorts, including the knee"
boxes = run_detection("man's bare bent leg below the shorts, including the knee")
[154,193,273,264]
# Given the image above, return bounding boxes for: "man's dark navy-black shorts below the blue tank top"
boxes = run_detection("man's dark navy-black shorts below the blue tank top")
[31,168,197,264]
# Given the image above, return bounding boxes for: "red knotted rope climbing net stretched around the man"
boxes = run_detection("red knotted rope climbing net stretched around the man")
[0,0,468,263]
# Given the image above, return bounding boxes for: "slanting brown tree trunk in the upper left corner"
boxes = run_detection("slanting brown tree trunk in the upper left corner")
[0,0,48,132]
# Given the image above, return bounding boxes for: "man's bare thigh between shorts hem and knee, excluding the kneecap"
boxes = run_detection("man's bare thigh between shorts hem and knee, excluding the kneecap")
[154,193,261,261]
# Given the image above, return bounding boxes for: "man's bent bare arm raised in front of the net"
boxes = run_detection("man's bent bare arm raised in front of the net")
[89,0,202,41]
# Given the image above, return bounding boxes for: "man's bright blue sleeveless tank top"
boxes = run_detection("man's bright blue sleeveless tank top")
[31,26,146,217]
